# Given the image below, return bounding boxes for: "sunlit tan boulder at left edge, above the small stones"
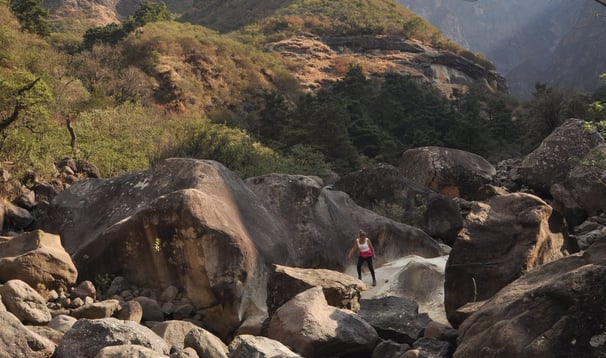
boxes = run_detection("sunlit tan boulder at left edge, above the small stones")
[0,230,78,289]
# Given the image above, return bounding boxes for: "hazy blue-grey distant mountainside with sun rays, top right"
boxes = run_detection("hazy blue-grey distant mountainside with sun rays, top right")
[399,0,606,97]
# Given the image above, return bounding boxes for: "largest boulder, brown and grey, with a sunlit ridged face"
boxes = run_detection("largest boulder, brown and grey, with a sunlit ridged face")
[41,159,290,337]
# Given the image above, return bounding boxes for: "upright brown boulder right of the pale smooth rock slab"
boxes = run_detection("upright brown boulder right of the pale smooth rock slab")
[444,193,564,327]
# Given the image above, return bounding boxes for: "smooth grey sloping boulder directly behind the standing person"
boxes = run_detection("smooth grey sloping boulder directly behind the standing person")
[246,174,442,271]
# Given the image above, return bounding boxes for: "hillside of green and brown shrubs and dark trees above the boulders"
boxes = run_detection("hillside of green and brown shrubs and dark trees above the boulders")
[0,0,595,187]
